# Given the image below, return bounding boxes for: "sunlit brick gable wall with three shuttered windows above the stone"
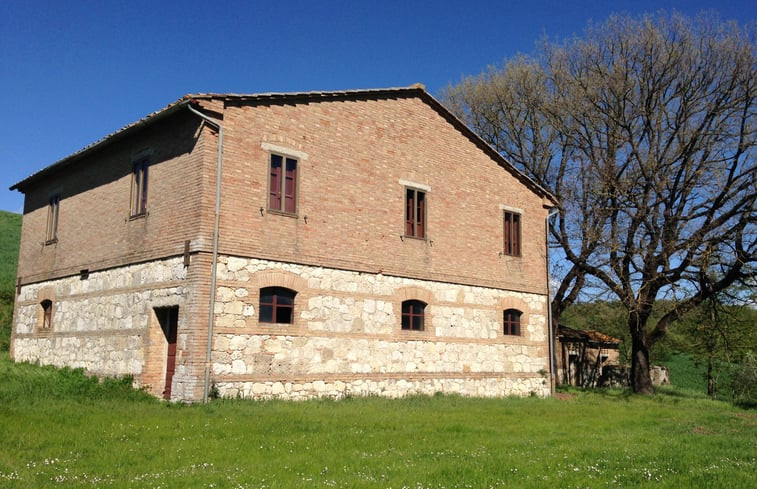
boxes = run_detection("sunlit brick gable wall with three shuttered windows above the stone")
[211,98,546,293]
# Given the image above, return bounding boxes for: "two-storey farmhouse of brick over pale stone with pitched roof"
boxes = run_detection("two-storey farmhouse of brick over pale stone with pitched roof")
[11,85,555,401]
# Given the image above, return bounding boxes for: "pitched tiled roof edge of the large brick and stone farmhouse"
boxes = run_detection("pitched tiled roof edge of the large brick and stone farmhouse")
[10,83,557,205]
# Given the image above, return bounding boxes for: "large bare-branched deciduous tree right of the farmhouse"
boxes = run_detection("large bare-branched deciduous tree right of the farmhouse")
[443,14,757,393]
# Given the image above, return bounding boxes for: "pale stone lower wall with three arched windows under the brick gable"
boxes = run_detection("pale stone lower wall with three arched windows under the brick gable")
[212,256,549,399]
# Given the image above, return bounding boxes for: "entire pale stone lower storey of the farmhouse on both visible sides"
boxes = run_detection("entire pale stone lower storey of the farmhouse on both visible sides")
[12,256,549,401]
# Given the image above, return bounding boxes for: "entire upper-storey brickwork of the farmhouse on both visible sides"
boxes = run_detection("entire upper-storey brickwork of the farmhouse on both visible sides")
[19,97,546,293]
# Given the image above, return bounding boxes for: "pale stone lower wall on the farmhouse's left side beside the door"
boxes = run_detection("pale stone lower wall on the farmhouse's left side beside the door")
[11,258,188,388]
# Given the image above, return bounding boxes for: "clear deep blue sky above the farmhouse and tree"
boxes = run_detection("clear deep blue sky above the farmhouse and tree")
[0,0,757,212]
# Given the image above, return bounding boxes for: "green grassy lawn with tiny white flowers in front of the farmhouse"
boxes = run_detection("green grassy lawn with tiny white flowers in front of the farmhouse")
[0,353,757,489]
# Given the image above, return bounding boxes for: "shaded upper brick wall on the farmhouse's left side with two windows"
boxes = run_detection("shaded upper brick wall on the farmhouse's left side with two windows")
[18,111,215,283]
